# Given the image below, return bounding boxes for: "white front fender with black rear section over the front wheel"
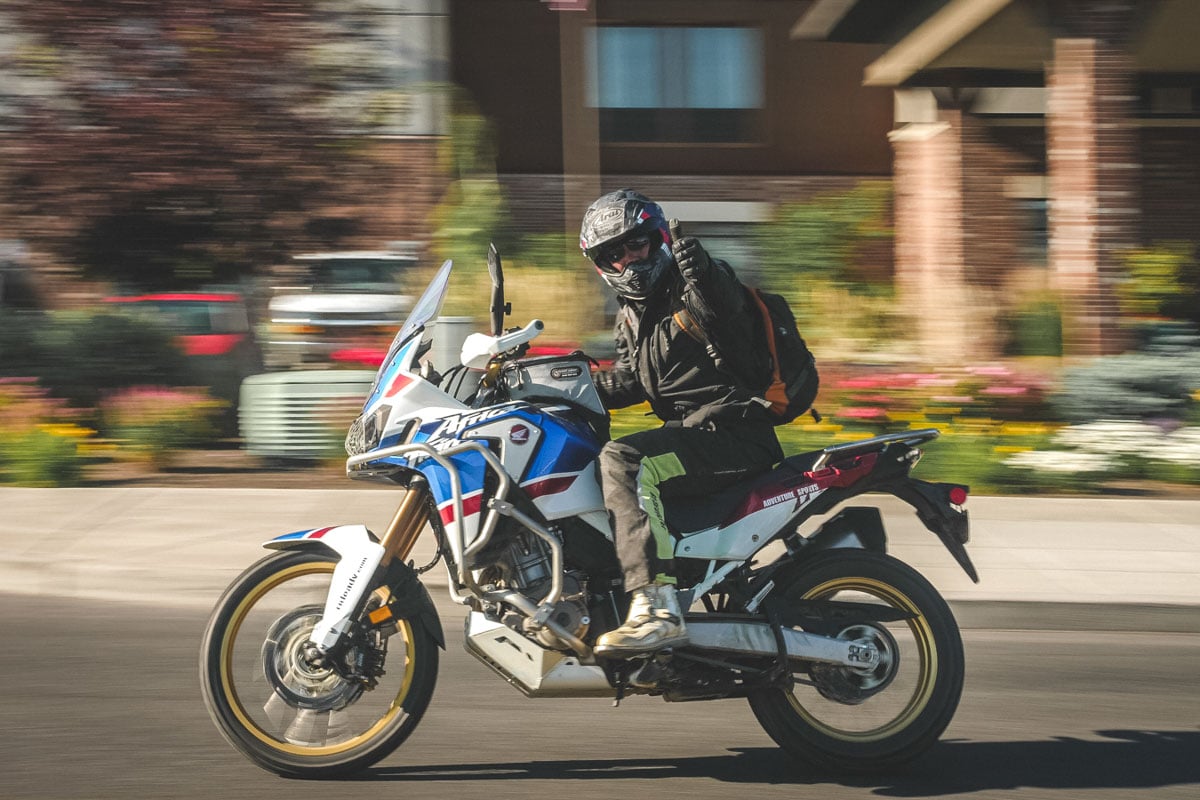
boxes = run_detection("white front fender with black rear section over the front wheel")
[263,525,445,650]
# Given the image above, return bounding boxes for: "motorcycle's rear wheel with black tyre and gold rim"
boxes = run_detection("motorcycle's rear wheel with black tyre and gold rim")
[749,549,964,771]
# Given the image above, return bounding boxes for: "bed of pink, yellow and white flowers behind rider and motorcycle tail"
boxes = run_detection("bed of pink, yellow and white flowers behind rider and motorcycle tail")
[612,366,1200,494]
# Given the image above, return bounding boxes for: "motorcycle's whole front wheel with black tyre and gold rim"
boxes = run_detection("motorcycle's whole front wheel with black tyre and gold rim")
[200,551,438,777]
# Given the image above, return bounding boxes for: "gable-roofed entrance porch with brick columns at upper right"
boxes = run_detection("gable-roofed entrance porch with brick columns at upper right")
[802,0,1200,355]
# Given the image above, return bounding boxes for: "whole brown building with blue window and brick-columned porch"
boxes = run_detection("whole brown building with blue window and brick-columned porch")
[450,0,1200,360]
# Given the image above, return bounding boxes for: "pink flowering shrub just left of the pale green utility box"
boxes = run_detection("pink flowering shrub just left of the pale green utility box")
[100,386,224,465]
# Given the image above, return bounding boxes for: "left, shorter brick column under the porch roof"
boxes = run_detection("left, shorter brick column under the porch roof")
[888,109,971,363]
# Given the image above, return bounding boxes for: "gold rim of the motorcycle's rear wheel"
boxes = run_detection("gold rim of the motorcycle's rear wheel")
[786,577,938,744]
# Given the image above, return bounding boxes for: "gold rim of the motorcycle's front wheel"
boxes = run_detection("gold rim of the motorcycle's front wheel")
[220,561,415,757]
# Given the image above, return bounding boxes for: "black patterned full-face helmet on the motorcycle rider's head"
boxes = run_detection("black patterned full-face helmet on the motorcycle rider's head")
[580,188,672,300]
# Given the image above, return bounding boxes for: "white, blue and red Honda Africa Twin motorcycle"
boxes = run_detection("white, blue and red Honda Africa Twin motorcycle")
[200,247,978,778]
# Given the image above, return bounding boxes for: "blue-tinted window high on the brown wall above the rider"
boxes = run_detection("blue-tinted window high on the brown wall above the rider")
[586,26,763,143]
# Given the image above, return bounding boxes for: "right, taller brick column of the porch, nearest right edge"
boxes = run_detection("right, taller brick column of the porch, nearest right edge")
[1046,37,1140,355]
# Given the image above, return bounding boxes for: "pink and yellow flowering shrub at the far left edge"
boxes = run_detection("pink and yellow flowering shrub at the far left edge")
[0,378,94,486]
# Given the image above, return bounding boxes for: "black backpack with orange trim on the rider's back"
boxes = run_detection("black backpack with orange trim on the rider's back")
[674,287,821,425]
